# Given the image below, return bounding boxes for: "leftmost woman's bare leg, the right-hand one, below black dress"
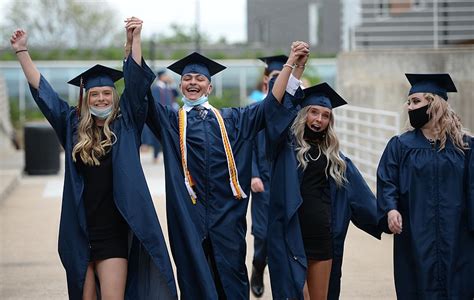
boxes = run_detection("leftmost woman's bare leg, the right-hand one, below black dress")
[96,258,127,300]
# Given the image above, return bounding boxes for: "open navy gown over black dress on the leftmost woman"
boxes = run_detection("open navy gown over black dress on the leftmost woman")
[30,57,177,300]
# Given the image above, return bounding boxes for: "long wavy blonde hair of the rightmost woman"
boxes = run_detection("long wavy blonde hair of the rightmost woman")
[410,93,471,151]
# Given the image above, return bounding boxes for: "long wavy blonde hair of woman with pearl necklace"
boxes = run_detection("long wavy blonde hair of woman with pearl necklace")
[291,106,347,187]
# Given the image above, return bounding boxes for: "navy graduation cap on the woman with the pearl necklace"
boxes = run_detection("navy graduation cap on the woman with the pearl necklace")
[301,82,347,109]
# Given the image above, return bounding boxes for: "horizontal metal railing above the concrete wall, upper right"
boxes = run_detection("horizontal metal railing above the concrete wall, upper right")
[349,0,474,49]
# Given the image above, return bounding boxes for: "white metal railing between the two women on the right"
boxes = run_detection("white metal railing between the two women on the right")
[334,105,400,191]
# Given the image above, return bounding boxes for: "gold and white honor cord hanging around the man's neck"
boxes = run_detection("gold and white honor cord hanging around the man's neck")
[178,106,247,204]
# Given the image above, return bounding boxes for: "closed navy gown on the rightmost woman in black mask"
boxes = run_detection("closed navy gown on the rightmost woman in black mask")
[377,130,474,299]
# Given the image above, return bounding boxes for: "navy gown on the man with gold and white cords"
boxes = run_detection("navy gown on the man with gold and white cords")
[147,79,282,299]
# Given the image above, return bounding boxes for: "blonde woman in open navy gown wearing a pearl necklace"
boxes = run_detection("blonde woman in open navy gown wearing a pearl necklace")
[266,62,381,299]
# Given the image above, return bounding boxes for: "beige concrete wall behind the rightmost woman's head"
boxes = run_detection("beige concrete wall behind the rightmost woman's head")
[337,48,474,131]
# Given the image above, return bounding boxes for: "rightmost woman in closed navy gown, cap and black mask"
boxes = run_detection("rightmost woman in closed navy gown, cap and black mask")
[377,74,474,300]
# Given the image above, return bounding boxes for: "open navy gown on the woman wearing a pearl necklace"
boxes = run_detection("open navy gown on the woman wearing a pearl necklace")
[265,94,381,299]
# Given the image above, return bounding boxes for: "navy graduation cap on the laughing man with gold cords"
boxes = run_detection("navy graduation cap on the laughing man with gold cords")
[168,52,226,81]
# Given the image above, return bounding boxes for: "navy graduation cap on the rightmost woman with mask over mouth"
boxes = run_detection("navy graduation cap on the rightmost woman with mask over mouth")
[405,73,457,100]
